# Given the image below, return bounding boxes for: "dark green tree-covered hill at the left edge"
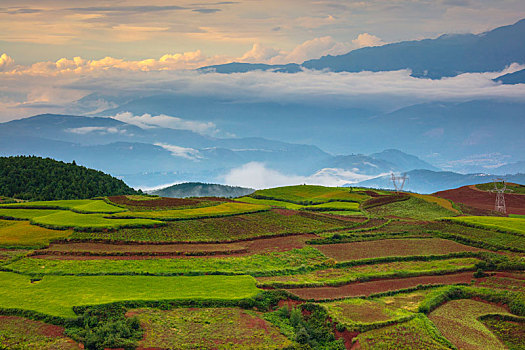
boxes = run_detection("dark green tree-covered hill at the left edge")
[0,156,137,200]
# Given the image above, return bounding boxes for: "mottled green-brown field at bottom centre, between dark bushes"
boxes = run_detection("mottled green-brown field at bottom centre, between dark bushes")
[130,308,293,350]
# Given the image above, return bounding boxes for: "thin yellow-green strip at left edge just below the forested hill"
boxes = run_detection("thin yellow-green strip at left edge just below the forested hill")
[0,199,126,214]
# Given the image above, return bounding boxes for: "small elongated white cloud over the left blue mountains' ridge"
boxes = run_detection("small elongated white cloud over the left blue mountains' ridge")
[109,112,219,135]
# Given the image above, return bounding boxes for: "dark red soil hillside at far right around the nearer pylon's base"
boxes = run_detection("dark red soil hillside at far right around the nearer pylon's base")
[434,186,525,215]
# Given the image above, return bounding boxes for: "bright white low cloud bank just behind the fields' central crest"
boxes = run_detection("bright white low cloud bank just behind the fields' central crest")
[219,162,385,189]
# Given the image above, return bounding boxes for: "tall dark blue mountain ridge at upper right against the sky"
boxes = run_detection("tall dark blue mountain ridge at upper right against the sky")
[202,19,525,79]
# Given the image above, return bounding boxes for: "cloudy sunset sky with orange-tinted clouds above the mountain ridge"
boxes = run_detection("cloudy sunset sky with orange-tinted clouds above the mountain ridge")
[0,0,525,69]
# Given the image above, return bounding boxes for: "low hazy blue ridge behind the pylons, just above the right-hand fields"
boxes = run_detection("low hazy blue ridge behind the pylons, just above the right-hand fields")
[348,170,525,193]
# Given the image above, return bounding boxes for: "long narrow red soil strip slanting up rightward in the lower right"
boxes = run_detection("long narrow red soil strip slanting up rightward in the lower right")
[287,272,473,300]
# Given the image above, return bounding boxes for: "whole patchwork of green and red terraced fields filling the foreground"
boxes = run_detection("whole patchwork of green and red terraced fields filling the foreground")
[0,185,525,350]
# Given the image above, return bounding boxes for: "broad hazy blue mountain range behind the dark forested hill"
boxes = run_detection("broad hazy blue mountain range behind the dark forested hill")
[0,114,437,187]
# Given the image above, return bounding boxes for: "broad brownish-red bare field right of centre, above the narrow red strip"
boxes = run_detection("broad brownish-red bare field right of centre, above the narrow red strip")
[315,238,483,261]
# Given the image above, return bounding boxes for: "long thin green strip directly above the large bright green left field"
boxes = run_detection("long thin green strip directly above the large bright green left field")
[6,247,328,275]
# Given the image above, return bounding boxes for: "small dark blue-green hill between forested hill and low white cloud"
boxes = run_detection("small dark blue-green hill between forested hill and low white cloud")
[148,182,255,198]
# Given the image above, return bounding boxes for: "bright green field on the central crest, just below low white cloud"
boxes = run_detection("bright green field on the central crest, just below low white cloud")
[252,185,370,204]
